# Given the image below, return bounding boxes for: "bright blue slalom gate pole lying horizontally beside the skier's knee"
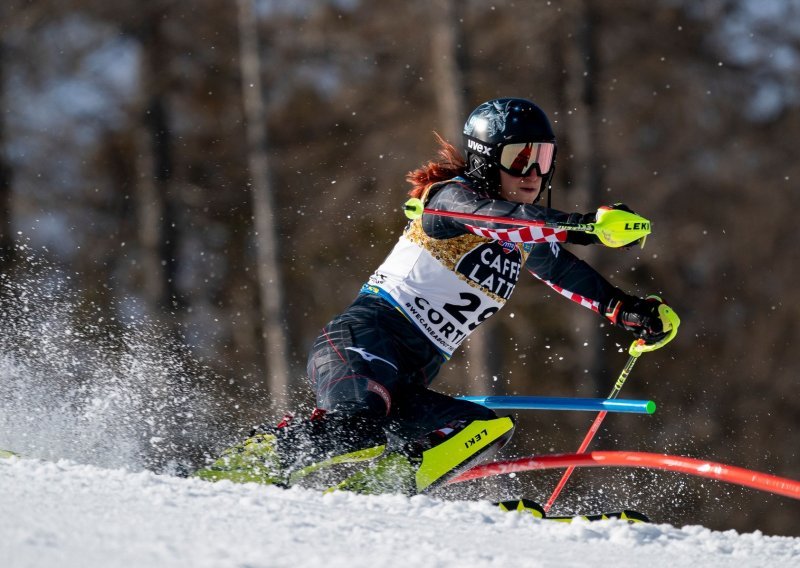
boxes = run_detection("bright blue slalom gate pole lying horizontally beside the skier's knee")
[458,396,656,414]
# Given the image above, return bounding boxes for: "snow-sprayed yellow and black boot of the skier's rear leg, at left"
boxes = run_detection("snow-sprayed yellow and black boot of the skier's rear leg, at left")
[193,409,386,488]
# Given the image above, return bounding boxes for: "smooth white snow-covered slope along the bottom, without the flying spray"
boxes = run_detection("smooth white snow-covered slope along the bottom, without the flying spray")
[0,458,800,568]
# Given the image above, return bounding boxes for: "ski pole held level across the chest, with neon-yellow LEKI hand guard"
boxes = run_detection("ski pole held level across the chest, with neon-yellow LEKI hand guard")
[403,197,650,248]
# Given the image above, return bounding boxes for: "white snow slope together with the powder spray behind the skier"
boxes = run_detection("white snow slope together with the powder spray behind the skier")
[0,251,800,568]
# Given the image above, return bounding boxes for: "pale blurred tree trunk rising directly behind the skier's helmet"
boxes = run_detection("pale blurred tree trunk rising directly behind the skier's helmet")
[431,0,494,394]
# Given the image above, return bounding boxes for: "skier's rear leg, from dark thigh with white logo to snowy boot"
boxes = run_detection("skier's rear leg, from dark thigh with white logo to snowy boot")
[197,304,397,485]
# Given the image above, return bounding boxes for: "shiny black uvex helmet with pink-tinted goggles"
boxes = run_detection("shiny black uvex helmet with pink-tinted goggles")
[464,99,556,201]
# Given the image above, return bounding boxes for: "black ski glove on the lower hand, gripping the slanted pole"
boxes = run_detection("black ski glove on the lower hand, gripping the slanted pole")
[605,295,680,350]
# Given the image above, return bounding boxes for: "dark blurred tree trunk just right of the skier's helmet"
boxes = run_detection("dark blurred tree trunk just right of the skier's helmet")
[554,0,607,395]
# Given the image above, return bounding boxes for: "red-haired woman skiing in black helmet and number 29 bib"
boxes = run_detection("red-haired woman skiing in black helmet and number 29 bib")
[197,98,674,494]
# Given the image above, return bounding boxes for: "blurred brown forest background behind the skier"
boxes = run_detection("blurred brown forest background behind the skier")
[0,0,800,535]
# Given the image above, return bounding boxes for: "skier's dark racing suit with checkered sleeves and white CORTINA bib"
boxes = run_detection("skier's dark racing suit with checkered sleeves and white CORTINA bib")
[308,177,618,448]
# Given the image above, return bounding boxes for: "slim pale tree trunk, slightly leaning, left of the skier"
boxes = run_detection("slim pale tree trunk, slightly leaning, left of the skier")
[238,0,289,407]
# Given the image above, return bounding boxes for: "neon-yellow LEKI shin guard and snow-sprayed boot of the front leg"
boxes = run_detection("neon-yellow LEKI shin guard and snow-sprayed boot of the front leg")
[329,416,514,495]
